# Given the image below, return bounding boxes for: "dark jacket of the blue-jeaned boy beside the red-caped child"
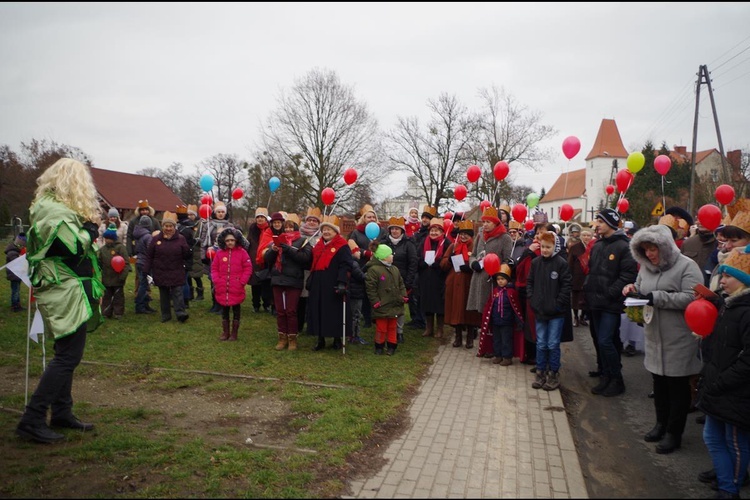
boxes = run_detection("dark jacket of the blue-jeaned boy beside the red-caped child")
[526,246,573,321]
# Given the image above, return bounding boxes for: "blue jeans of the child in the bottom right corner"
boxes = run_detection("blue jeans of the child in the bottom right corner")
[703,415,750,493]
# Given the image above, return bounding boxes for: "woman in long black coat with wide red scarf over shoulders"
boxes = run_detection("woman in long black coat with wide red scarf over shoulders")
[307,218,364,351]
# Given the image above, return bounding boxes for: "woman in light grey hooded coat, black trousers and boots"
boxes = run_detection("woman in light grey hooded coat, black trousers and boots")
[622,224,703,454]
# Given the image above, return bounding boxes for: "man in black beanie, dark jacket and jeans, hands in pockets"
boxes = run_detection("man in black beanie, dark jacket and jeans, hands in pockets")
[583,208,638,397]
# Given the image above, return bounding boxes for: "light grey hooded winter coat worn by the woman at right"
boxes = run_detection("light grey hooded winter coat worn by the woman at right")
[632,224,703,377]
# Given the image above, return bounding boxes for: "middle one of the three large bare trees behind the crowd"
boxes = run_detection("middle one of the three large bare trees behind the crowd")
[387,93,478,207]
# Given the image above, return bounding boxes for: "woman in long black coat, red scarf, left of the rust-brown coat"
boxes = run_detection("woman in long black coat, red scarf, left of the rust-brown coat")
[417,217,450,338]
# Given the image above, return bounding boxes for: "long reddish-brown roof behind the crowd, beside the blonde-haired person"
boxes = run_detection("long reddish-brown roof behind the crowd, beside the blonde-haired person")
[91,167,184,212]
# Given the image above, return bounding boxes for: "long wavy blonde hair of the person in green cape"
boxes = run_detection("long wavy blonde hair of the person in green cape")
[34,158,101,222]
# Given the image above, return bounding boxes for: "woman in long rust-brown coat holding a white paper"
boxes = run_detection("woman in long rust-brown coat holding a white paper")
[440,221,482,349]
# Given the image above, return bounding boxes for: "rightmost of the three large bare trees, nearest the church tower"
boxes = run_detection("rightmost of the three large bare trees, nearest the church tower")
[469,85,557,206]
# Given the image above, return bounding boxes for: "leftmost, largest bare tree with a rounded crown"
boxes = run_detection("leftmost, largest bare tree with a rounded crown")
[262,69,381,215]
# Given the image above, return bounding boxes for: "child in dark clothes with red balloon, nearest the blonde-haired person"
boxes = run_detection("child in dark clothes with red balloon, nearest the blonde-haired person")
[97,224,130,319]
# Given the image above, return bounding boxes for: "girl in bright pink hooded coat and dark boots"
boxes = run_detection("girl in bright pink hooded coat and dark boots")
[211,227,253,340]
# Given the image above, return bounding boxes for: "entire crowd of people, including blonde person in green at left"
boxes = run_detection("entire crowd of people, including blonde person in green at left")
[6,159,750,498]
